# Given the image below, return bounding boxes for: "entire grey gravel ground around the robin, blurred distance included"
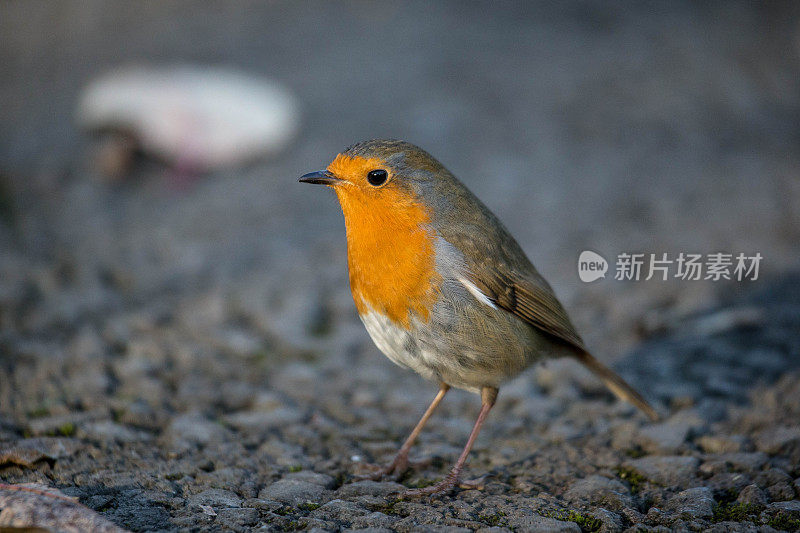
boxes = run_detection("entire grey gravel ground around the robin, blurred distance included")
[0,1,800,531]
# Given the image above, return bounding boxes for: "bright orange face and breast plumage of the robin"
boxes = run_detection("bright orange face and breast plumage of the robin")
[328,156,441,327]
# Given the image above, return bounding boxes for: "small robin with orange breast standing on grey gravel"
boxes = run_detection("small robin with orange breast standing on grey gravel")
[300,140,658,497]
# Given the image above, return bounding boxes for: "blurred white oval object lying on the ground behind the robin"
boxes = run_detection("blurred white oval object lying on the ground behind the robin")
[78,66,299,171]
